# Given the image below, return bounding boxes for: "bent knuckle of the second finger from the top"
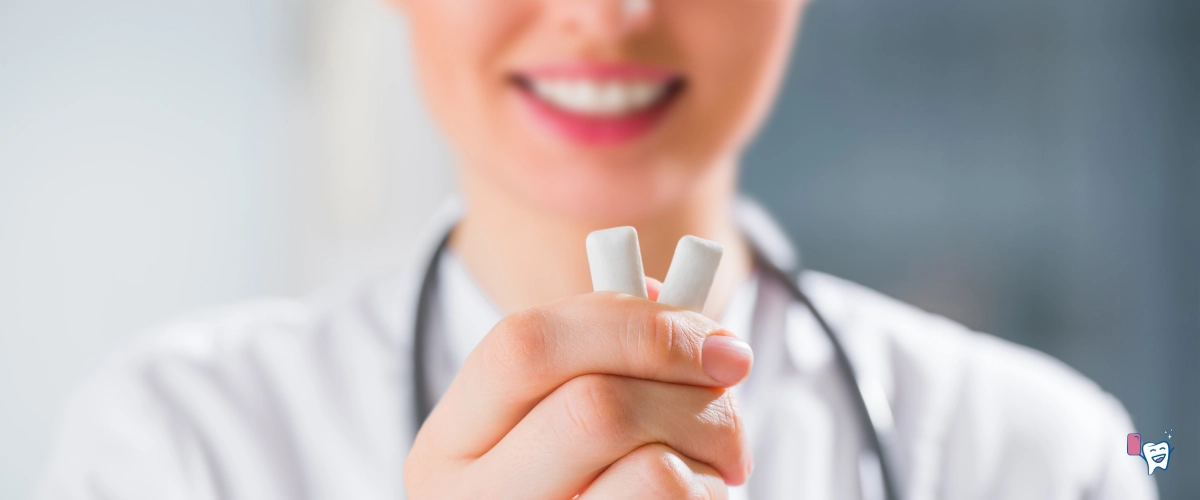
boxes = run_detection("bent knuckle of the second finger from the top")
[563,375,632,445]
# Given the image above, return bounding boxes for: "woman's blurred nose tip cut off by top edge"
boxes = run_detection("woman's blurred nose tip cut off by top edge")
[547,0,654,40]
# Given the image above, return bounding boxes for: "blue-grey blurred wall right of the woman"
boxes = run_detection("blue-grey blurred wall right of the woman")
[743,0,1200,499]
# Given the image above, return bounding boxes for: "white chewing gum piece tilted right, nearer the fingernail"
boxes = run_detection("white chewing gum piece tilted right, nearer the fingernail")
[659,236,725,313]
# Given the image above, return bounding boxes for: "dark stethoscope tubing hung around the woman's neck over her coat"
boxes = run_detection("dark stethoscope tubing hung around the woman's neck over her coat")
[413,203,900,500]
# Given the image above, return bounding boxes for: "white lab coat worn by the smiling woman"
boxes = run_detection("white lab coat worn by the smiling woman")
[38,196,1157,500]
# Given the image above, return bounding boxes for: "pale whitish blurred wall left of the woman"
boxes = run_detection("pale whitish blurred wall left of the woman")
[0,0,451,499]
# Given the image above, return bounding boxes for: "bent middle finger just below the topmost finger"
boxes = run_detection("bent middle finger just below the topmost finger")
[472,375,752,498]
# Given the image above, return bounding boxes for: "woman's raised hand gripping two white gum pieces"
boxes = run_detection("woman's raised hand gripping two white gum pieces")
[404,278,752,499]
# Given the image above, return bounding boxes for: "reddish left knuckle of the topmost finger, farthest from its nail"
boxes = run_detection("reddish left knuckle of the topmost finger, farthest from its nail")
[487,307,553,379]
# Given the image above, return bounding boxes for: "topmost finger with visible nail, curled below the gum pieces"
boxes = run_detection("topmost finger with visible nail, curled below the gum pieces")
[414,293,752,458]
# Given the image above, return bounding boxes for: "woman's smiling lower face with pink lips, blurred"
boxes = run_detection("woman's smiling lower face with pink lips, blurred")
[394,0,803,221]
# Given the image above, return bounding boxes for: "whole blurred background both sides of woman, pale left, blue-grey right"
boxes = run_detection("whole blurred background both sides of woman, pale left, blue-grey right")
[0,0,1200,499]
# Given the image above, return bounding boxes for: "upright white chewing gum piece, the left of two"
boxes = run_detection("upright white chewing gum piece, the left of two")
[587,225,648,299]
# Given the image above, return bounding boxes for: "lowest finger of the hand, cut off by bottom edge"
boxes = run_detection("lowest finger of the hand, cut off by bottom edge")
[578,442,728,500]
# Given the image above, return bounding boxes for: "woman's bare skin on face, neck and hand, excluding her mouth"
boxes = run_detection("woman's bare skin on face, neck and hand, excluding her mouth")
[392,0,803,499]
